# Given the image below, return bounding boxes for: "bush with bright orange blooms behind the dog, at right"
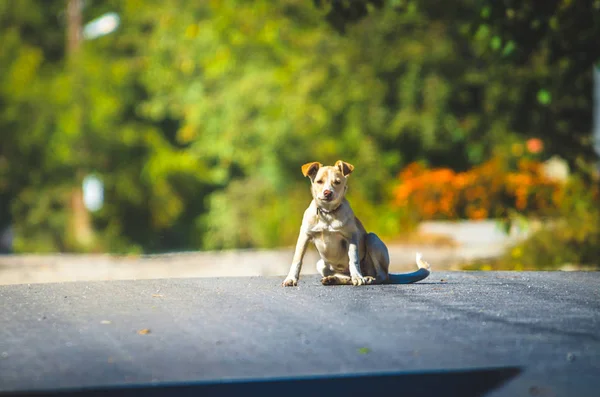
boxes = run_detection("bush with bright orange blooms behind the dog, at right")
[394,156,563,220]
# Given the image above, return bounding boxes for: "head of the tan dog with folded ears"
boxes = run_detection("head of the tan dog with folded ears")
[302,160,354,210]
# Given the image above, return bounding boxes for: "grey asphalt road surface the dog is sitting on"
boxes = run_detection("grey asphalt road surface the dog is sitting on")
[0,272,600,397]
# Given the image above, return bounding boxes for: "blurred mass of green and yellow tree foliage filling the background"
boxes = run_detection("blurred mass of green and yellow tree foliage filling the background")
[0,0,600,252]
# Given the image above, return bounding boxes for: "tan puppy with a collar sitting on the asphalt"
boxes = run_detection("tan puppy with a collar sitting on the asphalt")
[283,160,429,287]
